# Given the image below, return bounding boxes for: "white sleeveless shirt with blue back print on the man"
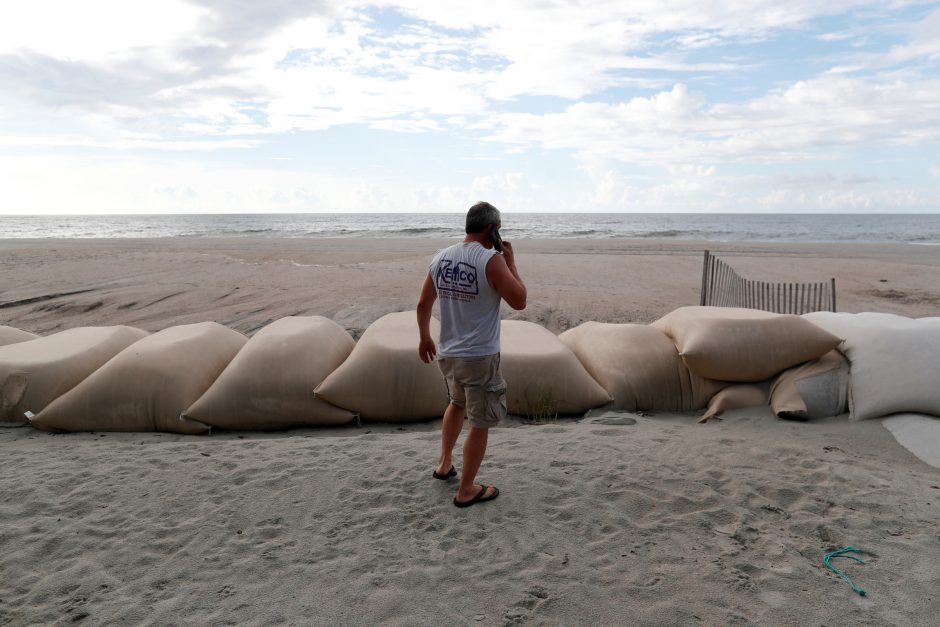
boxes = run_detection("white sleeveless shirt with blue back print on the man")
[428,242,500,357]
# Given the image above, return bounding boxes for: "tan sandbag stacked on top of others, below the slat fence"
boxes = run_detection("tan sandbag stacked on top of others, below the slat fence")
[650,307,841,383]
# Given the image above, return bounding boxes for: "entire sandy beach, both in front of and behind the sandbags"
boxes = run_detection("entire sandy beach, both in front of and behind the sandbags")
[0,238,940,626]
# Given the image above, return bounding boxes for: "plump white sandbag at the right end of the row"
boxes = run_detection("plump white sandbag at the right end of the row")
[803,312,940,420]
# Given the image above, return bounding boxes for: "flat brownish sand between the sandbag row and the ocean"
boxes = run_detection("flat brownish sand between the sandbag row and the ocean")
[0,238,940,337]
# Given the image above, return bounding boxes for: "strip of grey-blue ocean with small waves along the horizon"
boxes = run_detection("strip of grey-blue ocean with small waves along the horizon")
[0,212,940,245]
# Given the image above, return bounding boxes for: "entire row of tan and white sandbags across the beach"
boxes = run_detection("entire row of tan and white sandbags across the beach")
[0,307,940,433]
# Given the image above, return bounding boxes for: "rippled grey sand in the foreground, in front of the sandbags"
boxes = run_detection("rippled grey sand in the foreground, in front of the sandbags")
[0,411,940,626]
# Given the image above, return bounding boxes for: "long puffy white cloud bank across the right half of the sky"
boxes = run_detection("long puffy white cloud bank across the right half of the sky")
[489,75,940,164]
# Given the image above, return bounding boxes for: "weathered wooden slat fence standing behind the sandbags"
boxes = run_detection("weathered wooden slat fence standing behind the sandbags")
[701,250,836,315]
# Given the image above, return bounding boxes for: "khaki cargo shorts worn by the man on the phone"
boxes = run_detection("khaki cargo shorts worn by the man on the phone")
[437,353,506,429]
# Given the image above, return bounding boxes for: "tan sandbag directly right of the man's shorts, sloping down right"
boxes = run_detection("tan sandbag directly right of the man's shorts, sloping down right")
[500,320,611,417]
